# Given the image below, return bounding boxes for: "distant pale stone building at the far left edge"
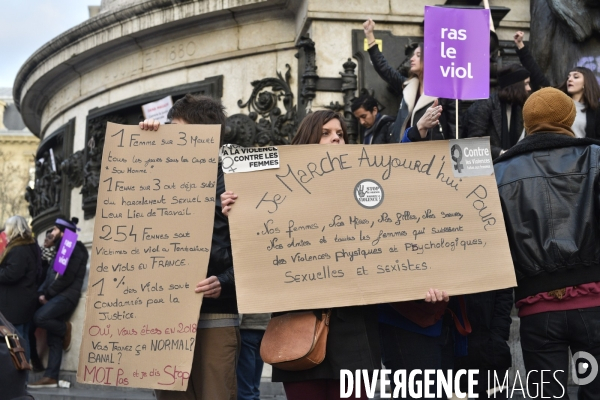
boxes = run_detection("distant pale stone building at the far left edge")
[0,88,40,226]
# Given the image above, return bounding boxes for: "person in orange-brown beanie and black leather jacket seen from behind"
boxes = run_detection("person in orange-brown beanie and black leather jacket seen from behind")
[494,88,600,399]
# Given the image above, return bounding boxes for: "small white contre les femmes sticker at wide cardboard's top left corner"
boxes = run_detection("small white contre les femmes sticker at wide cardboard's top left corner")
[219,144,279,174]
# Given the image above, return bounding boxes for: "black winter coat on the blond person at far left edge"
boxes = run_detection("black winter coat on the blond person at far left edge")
[0,238,41,325]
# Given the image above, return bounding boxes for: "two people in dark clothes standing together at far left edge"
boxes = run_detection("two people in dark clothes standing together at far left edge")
[0,215,89,392]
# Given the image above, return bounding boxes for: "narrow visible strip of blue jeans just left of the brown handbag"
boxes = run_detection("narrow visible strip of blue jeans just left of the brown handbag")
[237,329,265,400]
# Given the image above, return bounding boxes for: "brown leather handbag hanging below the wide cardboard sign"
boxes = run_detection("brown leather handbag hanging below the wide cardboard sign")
[260,310,331,371]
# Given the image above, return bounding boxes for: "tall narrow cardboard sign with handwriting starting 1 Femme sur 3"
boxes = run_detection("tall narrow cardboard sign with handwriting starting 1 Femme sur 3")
[77,123,221,390]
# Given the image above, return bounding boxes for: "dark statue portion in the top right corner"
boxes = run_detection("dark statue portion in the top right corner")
[529,0,600,85]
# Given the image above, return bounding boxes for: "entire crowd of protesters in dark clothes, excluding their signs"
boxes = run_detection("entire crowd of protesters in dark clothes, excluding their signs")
[0,20,600,400]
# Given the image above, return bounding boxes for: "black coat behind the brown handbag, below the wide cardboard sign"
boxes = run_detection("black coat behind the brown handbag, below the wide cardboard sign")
[273,306,381,382]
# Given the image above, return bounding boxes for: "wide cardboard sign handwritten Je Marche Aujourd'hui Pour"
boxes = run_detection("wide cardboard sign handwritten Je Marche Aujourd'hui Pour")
[225,139,516,313]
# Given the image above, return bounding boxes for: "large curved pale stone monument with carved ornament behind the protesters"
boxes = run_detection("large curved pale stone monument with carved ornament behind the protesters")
[14,0,529,388]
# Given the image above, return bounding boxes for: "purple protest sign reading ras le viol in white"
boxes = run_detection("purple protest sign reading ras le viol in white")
[423,6,490,100]
